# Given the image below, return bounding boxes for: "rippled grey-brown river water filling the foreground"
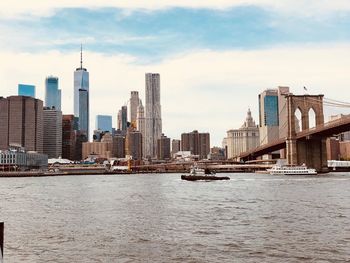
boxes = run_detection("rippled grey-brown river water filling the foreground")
[0,174,350,263]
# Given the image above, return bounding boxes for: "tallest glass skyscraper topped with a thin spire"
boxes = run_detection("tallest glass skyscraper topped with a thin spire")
[74,45,90,138]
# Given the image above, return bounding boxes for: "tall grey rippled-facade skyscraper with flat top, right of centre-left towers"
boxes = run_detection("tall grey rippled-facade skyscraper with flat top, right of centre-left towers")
[145,73,162,157]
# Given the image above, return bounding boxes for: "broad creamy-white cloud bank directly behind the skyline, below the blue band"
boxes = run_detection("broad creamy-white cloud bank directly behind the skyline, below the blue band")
[0,43,350,145]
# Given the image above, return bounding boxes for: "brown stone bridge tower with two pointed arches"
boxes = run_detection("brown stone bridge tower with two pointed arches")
[286,94,327,172]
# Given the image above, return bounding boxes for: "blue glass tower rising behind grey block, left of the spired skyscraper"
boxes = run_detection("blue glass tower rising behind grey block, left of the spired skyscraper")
[45,76,61,111]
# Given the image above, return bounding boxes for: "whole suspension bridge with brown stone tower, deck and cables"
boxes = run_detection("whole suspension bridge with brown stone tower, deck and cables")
[238,94,350,172]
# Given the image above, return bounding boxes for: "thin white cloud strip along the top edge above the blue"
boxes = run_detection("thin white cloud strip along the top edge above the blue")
[0,0,350,19]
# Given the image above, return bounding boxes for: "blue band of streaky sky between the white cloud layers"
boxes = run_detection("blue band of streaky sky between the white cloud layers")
[0,6,350,63]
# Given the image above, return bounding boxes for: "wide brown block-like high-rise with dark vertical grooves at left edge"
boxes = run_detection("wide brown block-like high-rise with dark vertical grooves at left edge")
[0,96,43,153]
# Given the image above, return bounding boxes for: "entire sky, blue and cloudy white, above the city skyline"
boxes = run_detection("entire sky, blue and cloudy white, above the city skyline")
[0,0,350,146]
